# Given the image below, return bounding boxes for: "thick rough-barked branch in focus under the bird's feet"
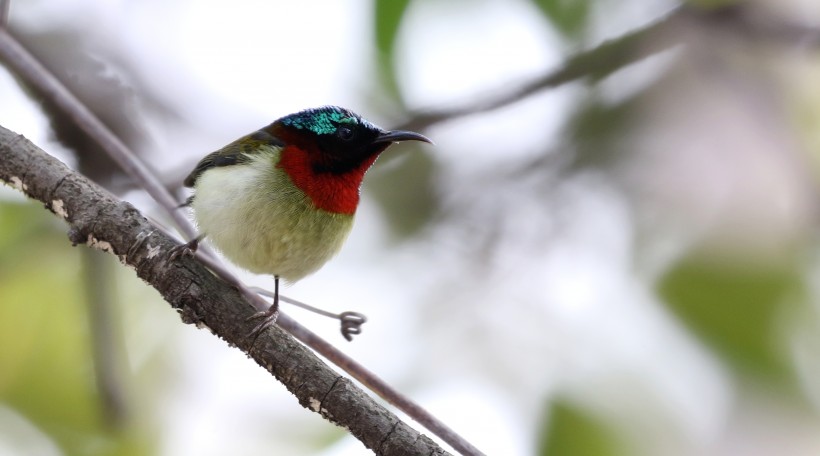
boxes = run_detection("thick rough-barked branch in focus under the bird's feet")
[0,127,462,455]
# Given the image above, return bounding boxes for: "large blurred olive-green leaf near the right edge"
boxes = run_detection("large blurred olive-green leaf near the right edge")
[659,256,806,388]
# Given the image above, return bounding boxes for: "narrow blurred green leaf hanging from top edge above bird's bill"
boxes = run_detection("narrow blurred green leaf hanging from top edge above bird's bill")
[373,0,410,104]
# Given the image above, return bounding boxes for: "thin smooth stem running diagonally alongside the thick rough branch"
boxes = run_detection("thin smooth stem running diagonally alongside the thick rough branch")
[0,28,481,454]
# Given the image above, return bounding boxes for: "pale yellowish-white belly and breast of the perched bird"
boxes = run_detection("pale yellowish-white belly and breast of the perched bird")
[191,154,353,282]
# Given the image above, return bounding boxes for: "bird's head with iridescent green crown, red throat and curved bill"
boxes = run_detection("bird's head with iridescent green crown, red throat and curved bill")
[264,106,432,213]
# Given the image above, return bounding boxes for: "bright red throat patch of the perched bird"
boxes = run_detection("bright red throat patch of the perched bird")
[276,146,378,215]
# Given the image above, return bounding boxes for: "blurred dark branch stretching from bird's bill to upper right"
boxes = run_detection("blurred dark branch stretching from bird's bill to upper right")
[396,2,820,131]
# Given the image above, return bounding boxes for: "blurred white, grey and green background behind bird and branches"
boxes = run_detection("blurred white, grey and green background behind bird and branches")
[0,0,820,456]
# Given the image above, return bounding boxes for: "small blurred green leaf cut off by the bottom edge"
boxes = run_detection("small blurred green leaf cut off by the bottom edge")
[538,400,630,456]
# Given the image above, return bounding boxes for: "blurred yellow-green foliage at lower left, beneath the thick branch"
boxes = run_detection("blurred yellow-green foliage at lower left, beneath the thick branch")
[0,203,151,455]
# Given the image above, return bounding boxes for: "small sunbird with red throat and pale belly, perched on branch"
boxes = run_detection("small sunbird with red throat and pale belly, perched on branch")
[181,106,432,339]
